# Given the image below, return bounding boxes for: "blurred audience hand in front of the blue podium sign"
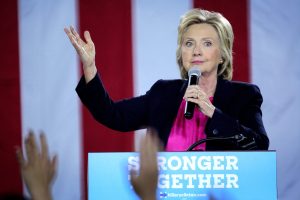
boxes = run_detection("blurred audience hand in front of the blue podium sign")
[130,129,159,200]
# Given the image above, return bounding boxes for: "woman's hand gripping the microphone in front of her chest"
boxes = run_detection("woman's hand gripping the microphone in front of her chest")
[183,85,215,118]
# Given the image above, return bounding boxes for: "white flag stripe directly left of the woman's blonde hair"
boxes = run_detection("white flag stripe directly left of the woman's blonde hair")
[132,0,193,149]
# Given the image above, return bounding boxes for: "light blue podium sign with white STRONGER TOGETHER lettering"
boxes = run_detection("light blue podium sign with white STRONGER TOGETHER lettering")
[88,151,277,200]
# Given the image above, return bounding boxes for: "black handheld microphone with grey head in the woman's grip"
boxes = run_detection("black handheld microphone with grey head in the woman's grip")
[184,66,201,119]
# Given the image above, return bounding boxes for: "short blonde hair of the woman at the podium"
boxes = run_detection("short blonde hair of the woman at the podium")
[176,9,234,80]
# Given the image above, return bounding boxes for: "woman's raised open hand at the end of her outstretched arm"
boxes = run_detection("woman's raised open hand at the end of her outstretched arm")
[64,26,97,83]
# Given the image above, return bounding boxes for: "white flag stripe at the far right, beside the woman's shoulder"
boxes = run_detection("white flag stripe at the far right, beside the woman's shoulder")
[250,0,300,200]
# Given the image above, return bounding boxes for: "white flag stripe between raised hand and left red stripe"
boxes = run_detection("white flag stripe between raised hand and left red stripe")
[19,0,82,200]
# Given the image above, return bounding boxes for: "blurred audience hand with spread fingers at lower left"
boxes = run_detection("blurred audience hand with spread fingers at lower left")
[16,131,57,200]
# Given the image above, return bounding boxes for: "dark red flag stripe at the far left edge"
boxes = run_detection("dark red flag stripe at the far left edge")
[0,0,22,194]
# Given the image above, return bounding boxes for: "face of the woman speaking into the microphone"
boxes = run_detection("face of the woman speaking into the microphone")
[181,24,222,77]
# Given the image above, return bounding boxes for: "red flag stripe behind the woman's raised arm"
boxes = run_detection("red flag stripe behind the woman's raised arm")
[79,0,133,198]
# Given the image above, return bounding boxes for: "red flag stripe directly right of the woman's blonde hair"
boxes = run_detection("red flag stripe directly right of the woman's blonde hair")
[194,0,251,82]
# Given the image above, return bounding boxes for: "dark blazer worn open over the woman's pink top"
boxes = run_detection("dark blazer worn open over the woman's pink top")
[76,74,269,150]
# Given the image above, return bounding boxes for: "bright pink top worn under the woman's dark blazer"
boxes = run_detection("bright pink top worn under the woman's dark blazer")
[166,97,213,151]
